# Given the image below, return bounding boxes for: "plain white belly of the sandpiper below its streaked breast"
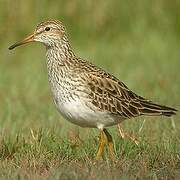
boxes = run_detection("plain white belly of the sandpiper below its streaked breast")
[55,98,120,129]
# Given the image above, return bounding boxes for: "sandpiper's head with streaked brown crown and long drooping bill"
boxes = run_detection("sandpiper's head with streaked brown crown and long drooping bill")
[9,20,66,50]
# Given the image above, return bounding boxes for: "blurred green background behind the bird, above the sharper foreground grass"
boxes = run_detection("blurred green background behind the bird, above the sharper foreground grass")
[0,0,180,143]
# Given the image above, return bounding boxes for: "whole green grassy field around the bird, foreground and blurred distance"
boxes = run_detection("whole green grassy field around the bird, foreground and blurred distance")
[0,0,180,179]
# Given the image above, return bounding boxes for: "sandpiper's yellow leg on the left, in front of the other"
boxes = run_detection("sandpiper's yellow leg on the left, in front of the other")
[96,130,106,160]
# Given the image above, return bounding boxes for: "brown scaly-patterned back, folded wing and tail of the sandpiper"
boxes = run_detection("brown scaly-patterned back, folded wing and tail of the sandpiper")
[72,59,177,118]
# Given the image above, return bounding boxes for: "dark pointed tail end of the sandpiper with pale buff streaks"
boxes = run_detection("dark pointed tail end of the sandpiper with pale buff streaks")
[139,101,177,117]
